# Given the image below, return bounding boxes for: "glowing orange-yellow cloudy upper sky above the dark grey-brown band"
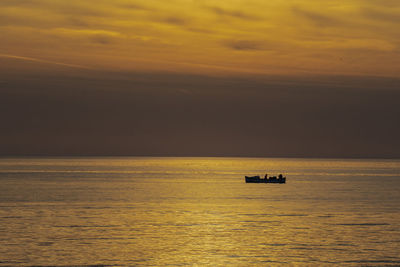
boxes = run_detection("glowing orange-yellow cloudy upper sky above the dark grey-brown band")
[0,0,400,77]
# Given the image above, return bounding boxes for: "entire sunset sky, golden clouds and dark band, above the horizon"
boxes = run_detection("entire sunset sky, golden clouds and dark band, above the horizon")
[0,0,400,158]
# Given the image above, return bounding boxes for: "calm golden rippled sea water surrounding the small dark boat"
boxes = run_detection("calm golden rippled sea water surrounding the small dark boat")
[0,158,400,266]
